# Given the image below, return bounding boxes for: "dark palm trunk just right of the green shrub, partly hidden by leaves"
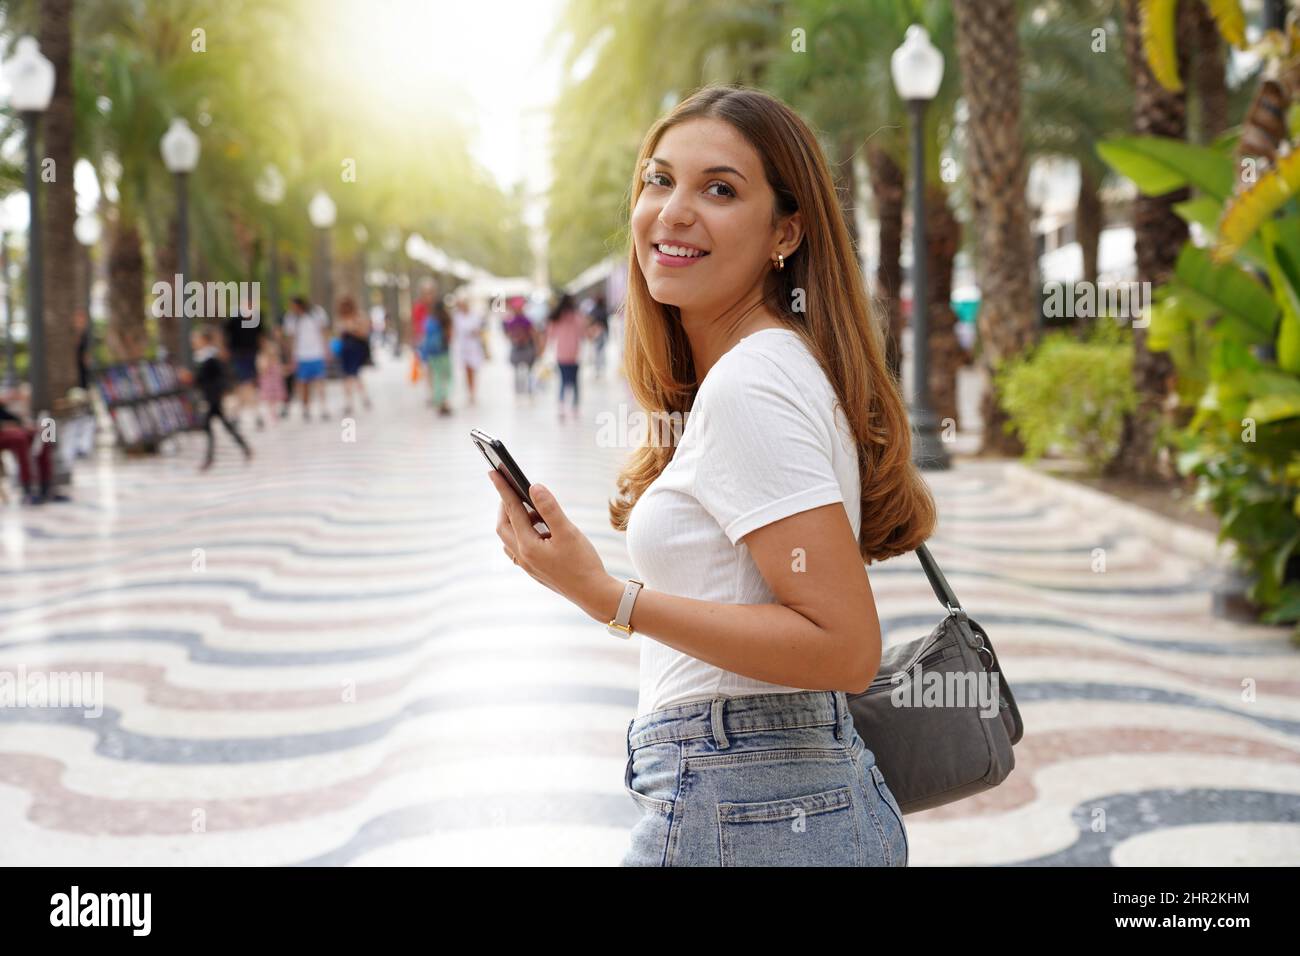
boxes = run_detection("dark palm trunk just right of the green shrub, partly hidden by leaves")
[1106,0,1190,479]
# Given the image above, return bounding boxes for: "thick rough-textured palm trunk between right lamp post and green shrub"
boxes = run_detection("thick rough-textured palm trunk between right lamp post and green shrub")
[953,0,1037,454]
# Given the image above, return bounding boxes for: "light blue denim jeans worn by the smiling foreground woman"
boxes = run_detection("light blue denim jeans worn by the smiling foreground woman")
[621,691,907,866]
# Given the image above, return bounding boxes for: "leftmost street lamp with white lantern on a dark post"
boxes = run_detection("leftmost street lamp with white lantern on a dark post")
[4,36,55,420]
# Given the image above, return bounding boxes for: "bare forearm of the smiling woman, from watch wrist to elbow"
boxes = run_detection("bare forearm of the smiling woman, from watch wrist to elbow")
[584,576,867,691]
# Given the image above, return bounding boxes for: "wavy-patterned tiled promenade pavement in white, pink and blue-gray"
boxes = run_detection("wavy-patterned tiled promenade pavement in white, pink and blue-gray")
[0,335,1300,865]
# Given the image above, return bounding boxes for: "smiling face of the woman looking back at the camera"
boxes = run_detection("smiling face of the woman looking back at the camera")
[632,118,790,312]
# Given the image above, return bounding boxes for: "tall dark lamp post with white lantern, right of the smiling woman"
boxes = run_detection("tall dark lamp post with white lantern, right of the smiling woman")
[889,23,952,470]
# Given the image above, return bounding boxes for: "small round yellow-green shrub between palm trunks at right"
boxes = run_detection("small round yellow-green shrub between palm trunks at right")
[996,320,1138,473]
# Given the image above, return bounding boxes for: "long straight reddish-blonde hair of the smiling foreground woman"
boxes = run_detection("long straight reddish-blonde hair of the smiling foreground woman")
[610,86,936,564]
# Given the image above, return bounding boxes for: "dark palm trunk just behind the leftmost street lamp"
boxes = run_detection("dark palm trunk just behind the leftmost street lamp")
[40,0,82,401]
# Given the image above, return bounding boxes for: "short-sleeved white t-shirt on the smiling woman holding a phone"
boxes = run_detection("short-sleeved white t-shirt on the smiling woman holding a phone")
[627,329,861,717]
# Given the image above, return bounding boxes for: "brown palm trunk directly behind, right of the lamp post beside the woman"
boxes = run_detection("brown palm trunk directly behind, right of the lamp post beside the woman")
[926,185,965,433]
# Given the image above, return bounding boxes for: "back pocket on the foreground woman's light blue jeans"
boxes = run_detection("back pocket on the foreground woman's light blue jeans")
[718,787,859,866]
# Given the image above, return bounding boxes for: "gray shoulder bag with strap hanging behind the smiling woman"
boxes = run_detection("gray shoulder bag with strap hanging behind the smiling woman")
[848,545,1024,813]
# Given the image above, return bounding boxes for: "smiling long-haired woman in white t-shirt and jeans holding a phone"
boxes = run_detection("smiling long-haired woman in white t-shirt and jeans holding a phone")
[493,87,935,866]
